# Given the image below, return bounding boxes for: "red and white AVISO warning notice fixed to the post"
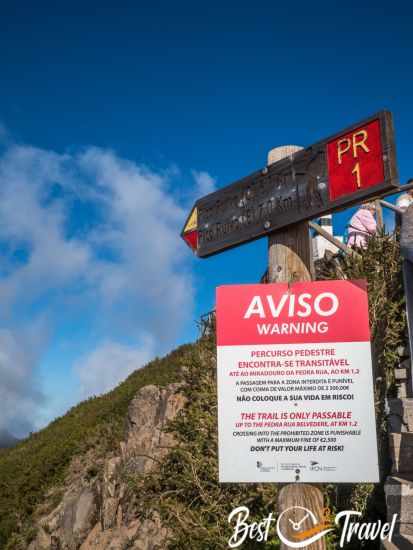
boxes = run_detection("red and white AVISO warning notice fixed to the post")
[217,281,379,483]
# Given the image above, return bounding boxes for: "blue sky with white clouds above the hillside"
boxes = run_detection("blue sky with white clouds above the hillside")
[0,1,413,435]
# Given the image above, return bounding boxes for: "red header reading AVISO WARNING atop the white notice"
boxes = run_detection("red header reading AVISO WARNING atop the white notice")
[217,281,370,346]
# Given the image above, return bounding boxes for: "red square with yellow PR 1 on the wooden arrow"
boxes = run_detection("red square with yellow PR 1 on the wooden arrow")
[327,119,384,201]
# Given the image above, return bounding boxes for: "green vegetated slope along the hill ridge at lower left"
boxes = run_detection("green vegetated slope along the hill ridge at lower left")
[0,345,190,548]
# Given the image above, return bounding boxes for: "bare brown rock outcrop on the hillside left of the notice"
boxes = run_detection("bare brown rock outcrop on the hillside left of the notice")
[29,384,185,550]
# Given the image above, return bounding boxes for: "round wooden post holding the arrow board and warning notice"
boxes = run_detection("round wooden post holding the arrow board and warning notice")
[268,145,326,550]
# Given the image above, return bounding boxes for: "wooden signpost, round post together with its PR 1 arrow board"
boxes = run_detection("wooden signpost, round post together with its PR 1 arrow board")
[181,111,398,550]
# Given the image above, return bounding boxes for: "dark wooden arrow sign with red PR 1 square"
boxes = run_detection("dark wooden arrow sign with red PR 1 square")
[182,111,398,258]
